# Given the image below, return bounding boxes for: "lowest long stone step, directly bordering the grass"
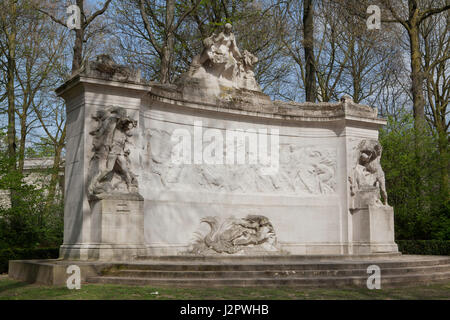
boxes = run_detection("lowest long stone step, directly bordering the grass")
[87,272,450,288]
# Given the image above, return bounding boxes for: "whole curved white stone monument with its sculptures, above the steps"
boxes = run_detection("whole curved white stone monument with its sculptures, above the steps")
[57,25,398,260]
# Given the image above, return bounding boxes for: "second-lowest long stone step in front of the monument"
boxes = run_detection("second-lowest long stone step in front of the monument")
[104,264,450,279]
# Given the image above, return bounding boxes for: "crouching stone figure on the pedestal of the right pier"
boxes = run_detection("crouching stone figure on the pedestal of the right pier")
[349,140,388,205]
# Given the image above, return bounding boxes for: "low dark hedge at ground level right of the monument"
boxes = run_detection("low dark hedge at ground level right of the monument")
[396,240,450,256]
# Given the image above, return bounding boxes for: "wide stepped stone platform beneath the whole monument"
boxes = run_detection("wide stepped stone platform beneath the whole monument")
[9,253,450,288]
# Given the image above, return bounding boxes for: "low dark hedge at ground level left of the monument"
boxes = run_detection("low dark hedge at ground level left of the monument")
[0,247,59,274]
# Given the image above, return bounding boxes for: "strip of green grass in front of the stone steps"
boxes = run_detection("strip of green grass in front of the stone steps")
[0,276,450,300]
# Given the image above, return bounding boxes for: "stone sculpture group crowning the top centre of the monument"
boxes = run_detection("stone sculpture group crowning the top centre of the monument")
[188,23,261,91]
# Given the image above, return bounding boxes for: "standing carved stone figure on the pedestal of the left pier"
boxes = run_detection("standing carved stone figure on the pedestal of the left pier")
[88,107,138,195]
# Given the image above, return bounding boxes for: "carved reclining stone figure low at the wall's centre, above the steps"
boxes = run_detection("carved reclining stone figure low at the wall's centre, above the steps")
[188,215,280,254]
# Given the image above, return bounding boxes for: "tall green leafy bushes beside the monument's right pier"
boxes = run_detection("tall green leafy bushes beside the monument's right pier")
[380,114,450,240]
